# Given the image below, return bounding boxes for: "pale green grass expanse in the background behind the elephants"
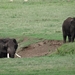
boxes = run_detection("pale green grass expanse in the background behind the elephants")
[0,0,75,40]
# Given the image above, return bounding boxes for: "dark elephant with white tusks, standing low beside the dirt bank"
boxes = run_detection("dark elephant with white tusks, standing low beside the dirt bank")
[0,38,18,58]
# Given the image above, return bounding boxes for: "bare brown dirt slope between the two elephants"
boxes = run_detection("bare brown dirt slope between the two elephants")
[18,40,63,57]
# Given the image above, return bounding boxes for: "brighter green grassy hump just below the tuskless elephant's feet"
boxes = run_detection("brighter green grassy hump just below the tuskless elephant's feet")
[57,43,75,55]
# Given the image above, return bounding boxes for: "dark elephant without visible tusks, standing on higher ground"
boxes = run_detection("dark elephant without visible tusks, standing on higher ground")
[62,17,75,43]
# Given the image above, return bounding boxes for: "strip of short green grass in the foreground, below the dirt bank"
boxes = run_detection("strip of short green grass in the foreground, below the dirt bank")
[0,55,75,75]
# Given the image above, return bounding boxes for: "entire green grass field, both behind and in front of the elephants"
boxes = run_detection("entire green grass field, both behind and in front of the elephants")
[0,0,75,75]
